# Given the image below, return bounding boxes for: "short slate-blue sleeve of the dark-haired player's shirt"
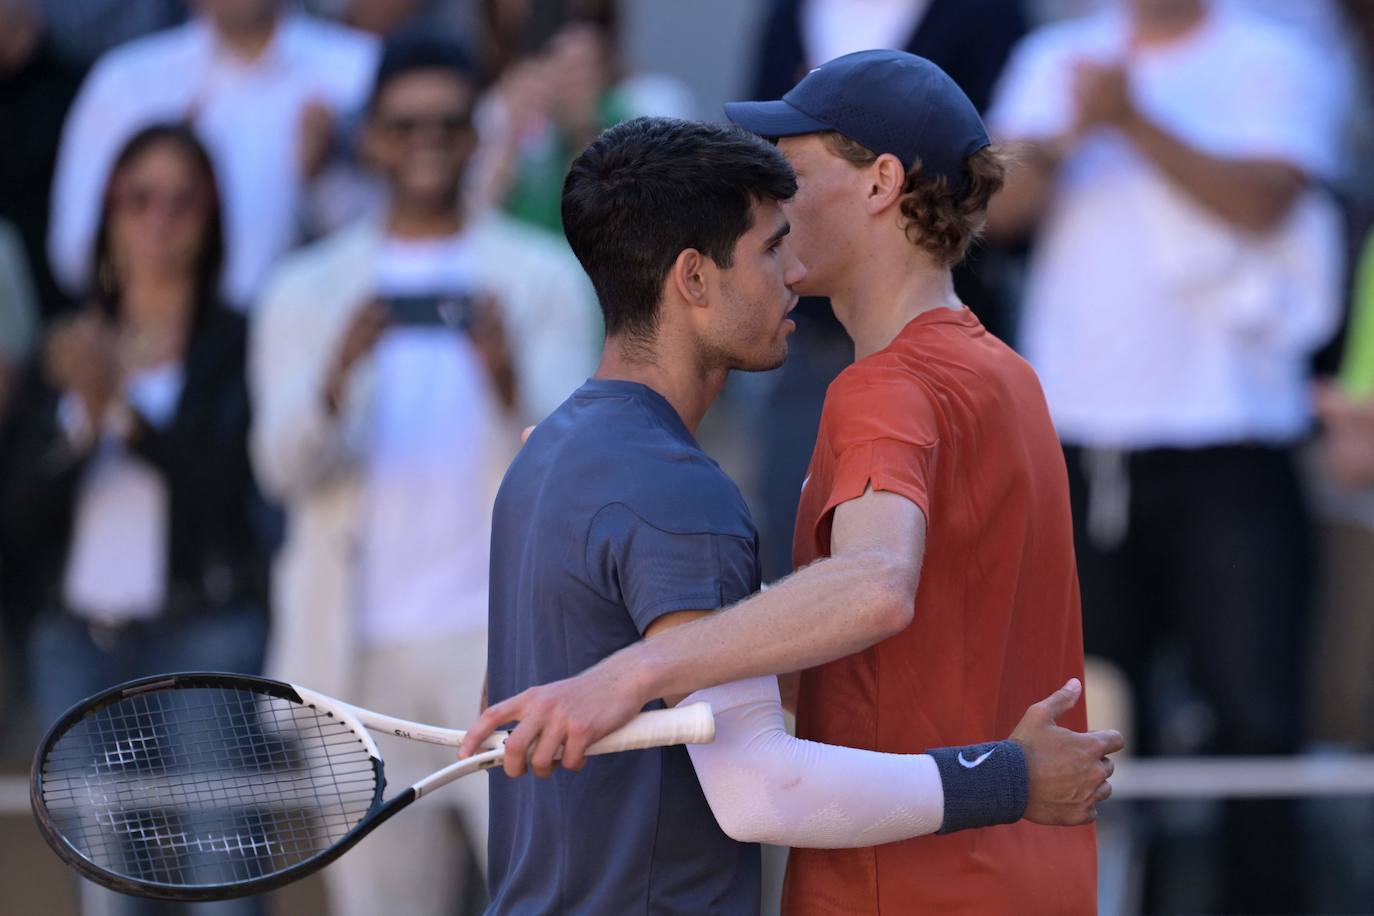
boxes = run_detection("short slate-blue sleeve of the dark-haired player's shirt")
[588,503,758,634]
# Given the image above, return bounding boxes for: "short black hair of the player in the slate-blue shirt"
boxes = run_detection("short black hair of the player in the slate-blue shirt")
[563,118,797,341]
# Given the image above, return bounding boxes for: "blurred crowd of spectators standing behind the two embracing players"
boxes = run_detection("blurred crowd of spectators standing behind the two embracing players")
[0,0,1374,915]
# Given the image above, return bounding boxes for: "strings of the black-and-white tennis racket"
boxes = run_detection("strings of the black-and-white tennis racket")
[41,687,378,887]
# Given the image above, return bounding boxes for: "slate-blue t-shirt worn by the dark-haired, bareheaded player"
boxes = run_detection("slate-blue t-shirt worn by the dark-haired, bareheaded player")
[488,379,760,915]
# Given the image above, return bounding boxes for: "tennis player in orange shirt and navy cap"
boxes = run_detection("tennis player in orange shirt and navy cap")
[470,51,1120,913]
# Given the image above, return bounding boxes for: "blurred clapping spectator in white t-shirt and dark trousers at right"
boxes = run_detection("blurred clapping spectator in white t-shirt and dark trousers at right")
[989,0,1349,912]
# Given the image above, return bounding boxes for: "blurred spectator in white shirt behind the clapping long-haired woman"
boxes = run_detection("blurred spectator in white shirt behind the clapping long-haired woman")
[48,0,376,308]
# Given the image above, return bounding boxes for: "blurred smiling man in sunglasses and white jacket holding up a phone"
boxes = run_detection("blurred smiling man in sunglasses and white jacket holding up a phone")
[250,33,598,916]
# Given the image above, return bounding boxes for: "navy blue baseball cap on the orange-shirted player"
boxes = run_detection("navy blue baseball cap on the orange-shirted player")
[725,51,992,188]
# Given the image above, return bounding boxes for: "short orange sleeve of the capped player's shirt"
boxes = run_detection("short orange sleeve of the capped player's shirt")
[816,367,940,540]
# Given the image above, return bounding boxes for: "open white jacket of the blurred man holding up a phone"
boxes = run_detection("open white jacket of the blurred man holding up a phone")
[249,213,599,698]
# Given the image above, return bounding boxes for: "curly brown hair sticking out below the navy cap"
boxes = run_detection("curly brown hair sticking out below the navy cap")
[820,130,1009,266]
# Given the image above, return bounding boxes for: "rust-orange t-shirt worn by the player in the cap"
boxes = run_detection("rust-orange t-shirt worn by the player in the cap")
[783,309,1096,916]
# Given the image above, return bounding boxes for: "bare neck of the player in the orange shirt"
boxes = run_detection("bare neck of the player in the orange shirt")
[830,243,963,360]
